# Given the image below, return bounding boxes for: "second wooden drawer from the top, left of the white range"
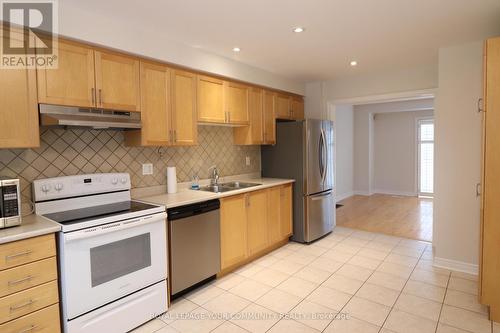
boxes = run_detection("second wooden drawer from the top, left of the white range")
[0,257,57,297]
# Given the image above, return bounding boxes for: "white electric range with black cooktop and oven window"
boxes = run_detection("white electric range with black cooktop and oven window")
[33,173,167,333]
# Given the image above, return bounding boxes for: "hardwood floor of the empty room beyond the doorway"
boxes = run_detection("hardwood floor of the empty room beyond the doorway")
[337,194,433,242]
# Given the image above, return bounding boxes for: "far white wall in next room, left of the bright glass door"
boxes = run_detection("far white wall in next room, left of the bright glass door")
[372,111,434,195]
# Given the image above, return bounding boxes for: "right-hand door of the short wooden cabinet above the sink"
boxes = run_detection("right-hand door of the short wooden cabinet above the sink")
[225,82,249,125]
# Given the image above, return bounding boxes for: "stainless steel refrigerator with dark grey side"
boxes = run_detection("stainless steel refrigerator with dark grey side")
[261,119,335,243]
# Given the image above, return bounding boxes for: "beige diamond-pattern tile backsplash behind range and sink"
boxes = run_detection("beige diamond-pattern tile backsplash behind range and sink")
[0,126,260,208]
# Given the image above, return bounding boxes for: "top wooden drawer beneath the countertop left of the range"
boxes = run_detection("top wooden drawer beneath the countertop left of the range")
[0,234,56,270]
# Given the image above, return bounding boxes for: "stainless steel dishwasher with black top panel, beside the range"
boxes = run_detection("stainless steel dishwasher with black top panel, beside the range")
[167,200,220,297]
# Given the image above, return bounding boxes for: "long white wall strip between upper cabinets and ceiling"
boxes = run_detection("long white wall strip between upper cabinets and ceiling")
[59,1,305,95]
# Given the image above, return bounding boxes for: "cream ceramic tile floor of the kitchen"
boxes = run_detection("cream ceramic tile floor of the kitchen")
[133,227,500,333]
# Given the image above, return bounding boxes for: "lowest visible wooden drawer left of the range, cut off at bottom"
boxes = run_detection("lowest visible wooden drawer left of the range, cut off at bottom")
[0,304,61,333]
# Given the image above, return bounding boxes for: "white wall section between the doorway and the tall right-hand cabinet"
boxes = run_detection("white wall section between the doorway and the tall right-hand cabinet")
[433,42,483,269]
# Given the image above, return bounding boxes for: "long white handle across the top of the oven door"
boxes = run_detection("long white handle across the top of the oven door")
[64,213,167,243]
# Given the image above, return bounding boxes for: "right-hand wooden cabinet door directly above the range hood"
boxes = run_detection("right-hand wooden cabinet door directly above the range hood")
[95,51,141,111]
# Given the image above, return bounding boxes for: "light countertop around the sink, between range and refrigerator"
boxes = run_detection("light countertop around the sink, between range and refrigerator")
[134,178,295,208]
